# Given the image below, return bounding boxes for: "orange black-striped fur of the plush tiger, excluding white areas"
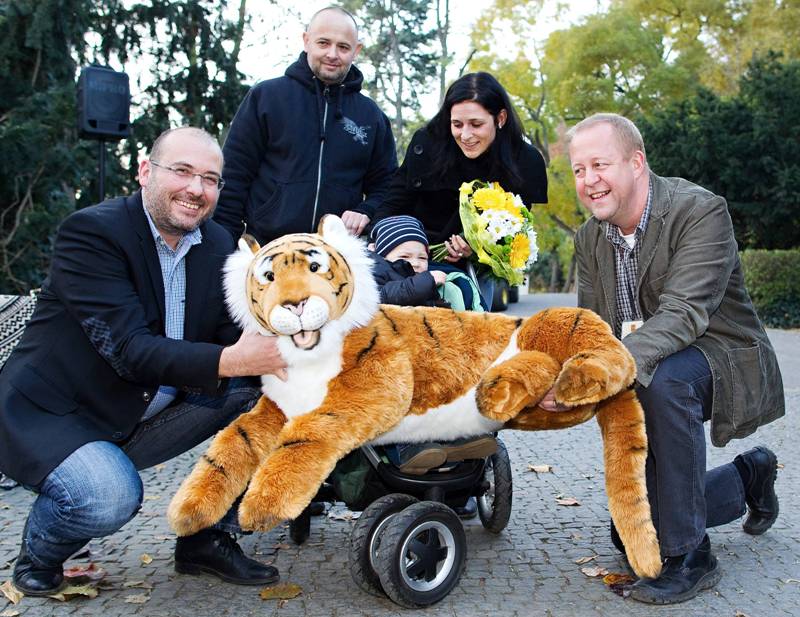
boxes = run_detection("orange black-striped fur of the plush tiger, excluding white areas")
[169,224,661,577]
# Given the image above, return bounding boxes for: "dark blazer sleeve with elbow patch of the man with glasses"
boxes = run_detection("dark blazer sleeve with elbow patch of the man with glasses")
[50,211,222,392]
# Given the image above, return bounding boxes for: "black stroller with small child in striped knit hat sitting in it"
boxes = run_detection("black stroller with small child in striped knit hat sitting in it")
[289,216,512,608]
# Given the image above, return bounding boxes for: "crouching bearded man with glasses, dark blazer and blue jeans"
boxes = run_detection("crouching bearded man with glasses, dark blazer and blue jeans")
[0,127,284,595]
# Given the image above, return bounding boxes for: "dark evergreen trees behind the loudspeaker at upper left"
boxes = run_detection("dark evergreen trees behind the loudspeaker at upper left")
[0,0,246,293]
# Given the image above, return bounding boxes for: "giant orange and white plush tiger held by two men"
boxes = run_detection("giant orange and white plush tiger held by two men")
[168,216,661,577]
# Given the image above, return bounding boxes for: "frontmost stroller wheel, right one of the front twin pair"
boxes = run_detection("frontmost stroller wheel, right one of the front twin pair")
[375,501,467,608]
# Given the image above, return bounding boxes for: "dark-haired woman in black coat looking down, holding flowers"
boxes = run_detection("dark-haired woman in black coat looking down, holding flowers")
[374,72,547,262]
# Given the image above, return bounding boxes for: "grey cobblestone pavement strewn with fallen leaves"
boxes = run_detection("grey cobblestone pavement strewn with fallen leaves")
[0,295,800,617]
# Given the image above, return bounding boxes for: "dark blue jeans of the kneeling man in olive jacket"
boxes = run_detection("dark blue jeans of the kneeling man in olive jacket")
[636,347,746,557]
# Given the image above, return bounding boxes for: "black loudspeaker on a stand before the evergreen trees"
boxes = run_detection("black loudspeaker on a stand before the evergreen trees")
[78,66,131,139]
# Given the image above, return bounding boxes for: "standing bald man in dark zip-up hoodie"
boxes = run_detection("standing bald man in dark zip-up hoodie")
[214,7,397,244]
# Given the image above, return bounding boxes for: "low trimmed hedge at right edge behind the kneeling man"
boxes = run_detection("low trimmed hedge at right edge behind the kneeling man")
[741,250,800,328]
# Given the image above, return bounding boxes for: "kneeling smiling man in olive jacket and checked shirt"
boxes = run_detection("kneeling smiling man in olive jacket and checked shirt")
[556,114,784,604]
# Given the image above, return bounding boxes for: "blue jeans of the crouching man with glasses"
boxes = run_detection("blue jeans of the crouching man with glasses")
[22,378,260,567]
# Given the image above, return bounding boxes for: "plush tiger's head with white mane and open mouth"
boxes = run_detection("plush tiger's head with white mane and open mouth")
[225,215,379,351]
